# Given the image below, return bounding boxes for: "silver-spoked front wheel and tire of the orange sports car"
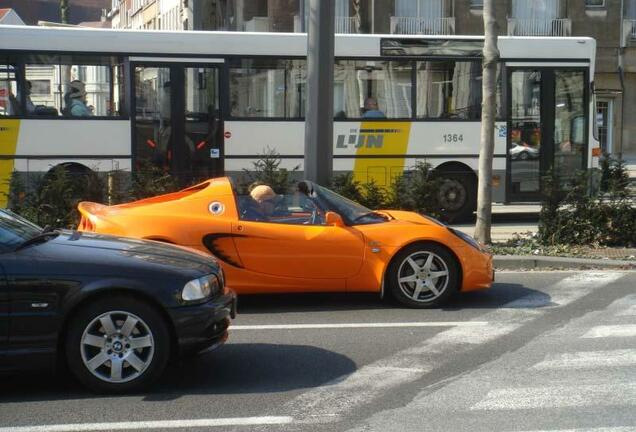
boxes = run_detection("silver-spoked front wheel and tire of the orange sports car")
[386,243,461,308]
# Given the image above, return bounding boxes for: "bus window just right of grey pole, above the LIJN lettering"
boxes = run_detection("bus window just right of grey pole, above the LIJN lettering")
[334,60,413,119]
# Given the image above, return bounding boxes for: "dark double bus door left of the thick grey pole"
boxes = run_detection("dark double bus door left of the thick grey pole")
[131,62,224,185]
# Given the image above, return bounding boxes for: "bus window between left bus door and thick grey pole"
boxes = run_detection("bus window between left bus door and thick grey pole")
[230,59,307,118]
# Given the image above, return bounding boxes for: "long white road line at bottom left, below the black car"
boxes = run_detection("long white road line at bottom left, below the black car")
[0,416,294,432]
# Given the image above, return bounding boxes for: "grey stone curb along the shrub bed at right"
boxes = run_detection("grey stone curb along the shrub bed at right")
[493,255,636,270]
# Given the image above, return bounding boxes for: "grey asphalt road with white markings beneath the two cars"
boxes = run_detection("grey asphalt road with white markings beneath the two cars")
[0,271,636,432]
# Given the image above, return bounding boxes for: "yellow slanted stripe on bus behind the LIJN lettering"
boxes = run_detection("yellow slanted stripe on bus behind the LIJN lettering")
[353,121,411,187]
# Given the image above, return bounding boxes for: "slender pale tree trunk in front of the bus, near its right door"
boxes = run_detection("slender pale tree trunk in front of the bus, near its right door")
[475,0,499,244]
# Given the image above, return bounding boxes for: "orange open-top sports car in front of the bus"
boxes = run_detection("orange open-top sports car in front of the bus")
[79,178,494,307]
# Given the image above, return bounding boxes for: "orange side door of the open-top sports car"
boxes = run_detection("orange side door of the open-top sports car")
[232,221,364,279]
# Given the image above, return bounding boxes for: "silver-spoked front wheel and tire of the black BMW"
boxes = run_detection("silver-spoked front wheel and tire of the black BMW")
[65,295,170,393]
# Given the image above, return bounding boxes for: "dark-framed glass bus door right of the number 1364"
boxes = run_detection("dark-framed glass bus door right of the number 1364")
[506,67,588,202]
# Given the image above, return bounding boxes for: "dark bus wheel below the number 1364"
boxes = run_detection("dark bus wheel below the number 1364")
[437,172,477,222]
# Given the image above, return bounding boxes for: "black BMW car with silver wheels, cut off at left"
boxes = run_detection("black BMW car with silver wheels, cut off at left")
[0,210,236,392]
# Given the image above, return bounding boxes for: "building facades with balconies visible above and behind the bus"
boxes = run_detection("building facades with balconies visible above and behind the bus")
[110,0,636,165]
